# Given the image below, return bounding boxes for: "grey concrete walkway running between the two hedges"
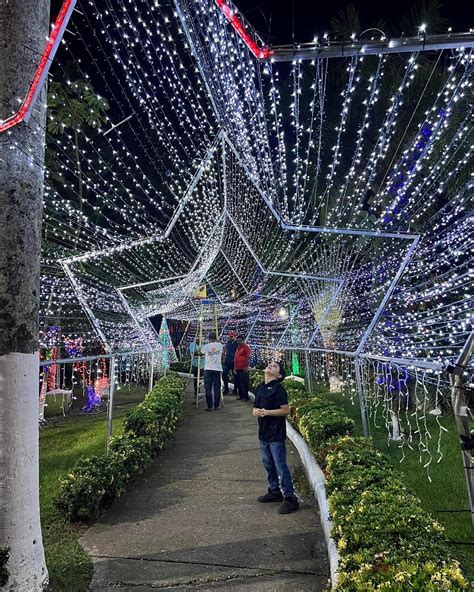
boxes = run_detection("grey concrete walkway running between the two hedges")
[82,387,328,592]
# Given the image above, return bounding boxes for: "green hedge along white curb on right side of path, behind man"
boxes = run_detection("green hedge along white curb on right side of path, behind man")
[251,371,470,592]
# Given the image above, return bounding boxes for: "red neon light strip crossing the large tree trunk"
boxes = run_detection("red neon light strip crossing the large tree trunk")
[0,0,76,133]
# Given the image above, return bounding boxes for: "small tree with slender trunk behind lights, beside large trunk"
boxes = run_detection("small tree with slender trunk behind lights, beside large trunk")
[48,80,109,245]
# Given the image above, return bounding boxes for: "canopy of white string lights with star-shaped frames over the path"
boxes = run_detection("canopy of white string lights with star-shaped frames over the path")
[30,0,473,374]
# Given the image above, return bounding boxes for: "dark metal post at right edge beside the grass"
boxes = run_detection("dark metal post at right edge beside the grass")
[450,332,474,524]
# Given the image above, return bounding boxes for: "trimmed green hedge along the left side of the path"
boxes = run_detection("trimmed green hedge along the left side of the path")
[55,374,186,522]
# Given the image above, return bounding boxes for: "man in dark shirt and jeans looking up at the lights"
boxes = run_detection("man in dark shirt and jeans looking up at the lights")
[252,361,300,514]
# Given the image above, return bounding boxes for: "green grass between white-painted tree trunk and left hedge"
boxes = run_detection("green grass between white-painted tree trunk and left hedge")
[40,408,131,592]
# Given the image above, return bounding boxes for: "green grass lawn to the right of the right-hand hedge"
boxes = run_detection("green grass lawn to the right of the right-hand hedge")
[327,393,474,580]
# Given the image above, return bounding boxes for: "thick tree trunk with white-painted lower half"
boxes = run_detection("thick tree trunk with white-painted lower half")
[0,0,49,592]
